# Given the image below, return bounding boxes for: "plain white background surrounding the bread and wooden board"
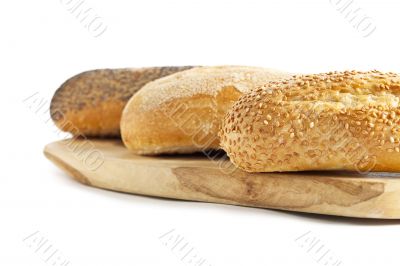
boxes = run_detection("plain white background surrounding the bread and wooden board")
[0,0,400,266]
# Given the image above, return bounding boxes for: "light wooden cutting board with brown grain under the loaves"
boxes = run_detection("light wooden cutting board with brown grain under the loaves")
[44,139,400,219]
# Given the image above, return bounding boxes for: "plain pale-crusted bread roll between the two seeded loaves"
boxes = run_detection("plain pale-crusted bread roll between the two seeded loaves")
[121,66,291,155]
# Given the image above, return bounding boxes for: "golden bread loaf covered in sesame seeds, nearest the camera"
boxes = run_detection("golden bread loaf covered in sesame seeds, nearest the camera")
[220,71,400,172]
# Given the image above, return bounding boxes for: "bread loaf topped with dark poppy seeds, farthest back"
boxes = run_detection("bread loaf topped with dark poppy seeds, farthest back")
[50,66,192,137]
